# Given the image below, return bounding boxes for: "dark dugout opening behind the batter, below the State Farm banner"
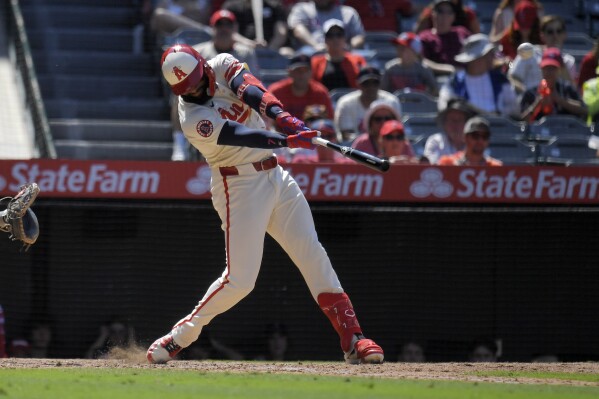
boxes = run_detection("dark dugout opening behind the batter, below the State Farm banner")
[0,197,599,361]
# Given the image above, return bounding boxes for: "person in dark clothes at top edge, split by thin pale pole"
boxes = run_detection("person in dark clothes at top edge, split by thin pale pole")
[222,0,290,54]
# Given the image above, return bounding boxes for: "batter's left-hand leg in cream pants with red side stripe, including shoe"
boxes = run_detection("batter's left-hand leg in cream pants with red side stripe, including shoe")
[148,176,274,363]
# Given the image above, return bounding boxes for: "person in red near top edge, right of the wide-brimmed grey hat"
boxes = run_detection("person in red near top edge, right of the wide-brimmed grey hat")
[498,0,543,60]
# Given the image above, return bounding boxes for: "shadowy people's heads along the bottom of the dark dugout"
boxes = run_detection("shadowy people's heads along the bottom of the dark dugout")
[0,306,560,363]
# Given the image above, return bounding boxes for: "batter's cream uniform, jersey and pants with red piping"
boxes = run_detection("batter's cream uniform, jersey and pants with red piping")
[172,54,343,347]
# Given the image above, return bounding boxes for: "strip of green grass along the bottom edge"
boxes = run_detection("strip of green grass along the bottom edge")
[0,368,599,399]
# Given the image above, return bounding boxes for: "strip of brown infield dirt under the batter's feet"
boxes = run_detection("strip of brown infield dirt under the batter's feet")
[0,353,599,386]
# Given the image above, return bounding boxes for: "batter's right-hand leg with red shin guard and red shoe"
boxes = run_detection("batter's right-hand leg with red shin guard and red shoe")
[267,167,384,363]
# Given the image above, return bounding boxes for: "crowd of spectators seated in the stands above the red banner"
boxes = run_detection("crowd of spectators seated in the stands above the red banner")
[139,0,599,165]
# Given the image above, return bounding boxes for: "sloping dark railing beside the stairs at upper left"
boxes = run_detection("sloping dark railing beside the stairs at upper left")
[8,0,56,158]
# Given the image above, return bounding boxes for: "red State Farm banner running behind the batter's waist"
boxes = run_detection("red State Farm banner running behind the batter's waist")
[0,159,599,204]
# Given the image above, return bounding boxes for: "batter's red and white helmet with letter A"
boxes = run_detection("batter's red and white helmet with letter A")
[160,44,215,96]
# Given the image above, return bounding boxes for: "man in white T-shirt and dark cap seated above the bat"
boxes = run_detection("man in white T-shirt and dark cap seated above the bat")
[335,66,401,143]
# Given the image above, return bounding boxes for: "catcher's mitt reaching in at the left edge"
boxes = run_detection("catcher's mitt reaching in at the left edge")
[0,183,40,251]
